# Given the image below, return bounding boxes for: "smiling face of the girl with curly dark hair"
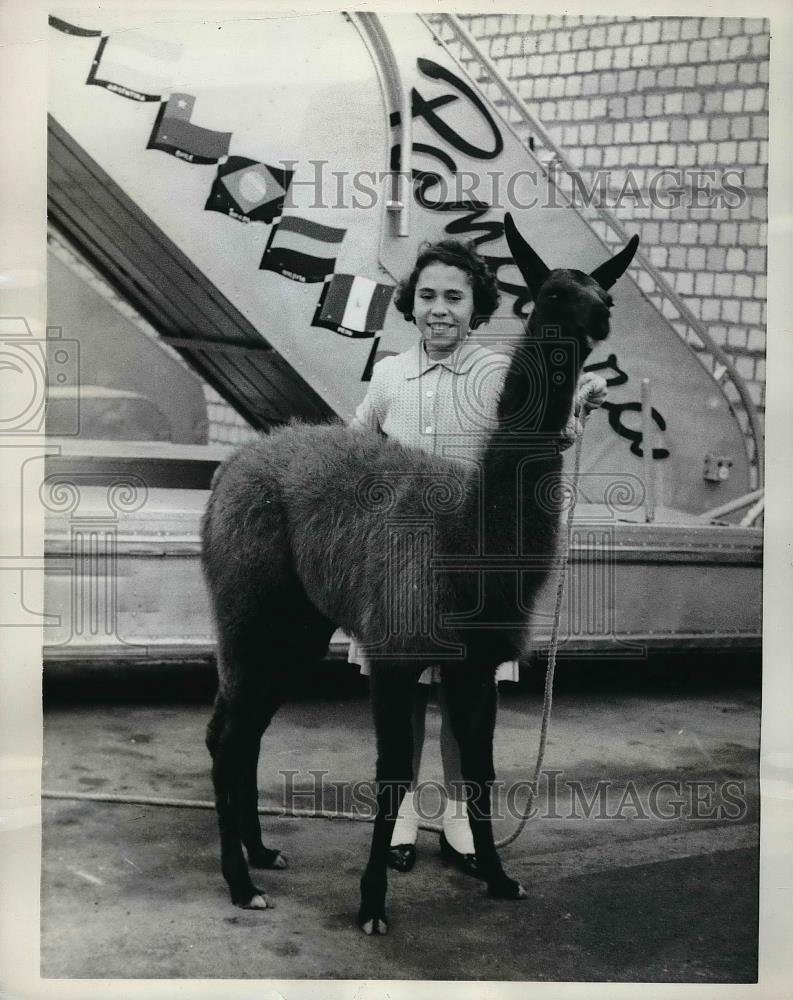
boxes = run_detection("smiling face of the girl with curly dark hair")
[413,261,474,358]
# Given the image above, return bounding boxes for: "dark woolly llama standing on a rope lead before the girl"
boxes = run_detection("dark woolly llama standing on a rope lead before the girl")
[202,213,638,934]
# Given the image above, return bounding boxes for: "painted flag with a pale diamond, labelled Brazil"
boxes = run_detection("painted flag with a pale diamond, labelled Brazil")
[204,156,294,222]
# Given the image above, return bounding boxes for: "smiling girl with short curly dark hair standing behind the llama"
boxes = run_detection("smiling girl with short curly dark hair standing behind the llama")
[348,240,607,875]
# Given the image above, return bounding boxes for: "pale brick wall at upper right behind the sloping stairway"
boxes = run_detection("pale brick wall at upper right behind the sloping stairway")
[462,14,769,416]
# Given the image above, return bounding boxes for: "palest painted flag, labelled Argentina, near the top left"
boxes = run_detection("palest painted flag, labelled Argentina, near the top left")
[86,32,182,101]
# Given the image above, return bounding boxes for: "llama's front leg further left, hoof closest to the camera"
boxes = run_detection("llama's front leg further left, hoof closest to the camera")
[358,663,422,934]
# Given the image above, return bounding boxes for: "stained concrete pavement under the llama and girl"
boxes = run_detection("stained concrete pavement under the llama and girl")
[41,666,760,983]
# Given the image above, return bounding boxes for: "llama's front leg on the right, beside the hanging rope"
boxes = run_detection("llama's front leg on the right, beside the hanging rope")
[442,664,527,899]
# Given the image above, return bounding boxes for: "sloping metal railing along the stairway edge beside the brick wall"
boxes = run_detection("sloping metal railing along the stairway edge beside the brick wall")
[419,14,765,487]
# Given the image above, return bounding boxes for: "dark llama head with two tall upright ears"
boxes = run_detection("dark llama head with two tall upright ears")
[504,212,639,354]
